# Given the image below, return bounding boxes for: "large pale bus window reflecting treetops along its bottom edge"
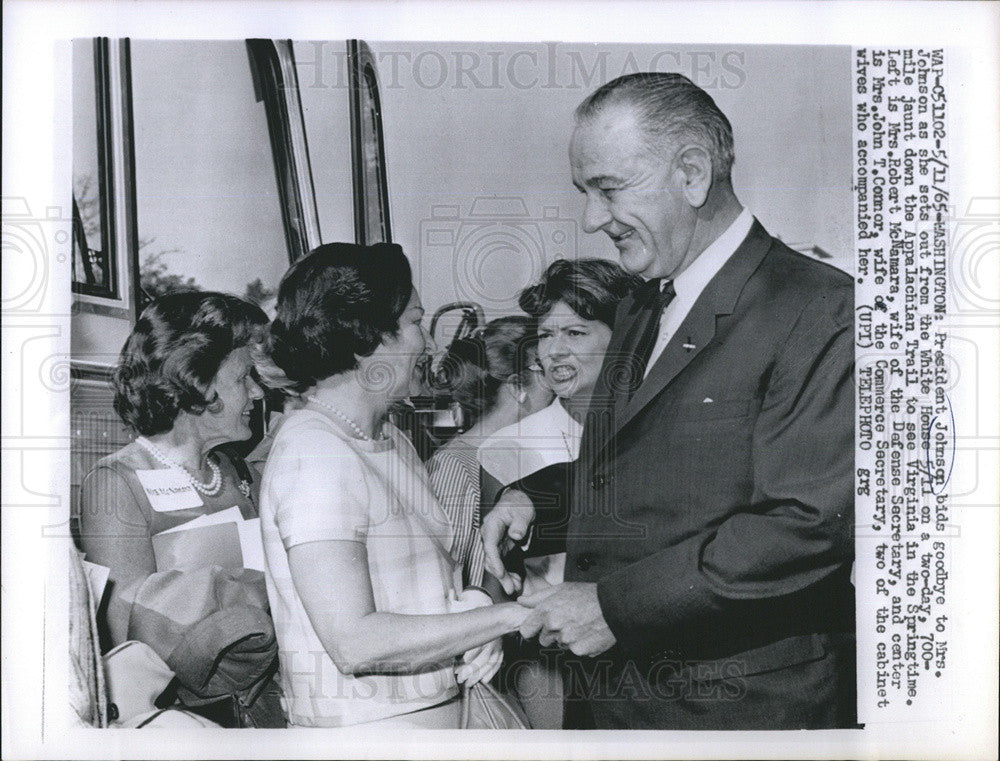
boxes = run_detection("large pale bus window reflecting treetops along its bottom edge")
[131,40,292,303]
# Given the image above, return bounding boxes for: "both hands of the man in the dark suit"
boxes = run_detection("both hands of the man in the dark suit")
[482,491,615,656]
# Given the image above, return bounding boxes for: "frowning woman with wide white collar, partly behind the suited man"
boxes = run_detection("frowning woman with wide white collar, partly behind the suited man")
[479,259,642,729]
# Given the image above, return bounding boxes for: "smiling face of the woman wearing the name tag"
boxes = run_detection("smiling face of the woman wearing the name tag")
[195,346,264,443]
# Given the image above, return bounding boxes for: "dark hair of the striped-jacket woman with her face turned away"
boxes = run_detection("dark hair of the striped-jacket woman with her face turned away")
[435,316,538,428]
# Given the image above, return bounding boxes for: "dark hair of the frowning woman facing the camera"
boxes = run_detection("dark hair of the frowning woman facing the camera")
[518,259,642,328]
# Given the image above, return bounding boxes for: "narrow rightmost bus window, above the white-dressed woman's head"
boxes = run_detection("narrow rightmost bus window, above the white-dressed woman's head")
[348,40,392,245]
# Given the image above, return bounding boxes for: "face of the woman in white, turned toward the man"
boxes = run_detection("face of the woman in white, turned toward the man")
[368,290,433,400]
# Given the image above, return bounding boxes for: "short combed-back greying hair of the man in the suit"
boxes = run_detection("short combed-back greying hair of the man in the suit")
[576,72,735,180]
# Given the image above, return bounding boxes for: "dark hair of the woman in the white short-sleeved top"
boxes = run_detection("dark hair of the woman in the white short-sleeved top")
[258,243,413,394]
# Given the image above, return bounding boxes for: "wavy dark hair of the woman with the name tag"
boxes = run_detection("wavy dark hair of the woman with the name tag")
[112,291,267,436]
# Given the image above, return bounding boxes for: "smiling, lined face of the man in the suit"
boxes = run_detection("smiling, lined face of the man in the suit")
[570,105,696,279]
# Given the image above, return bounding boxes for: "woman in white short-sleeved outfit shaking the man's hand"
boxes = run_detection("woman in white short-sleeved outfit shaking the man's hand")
[261,243,526,727]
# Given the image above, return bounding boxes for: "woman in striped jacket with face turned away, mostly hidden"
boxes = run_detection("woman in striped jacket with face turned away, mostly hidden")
[427,316,552,586]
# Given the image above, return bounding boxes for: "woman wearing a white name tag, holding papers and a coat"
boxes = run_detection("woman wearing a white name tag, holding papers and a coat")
[80,291,284,726]
